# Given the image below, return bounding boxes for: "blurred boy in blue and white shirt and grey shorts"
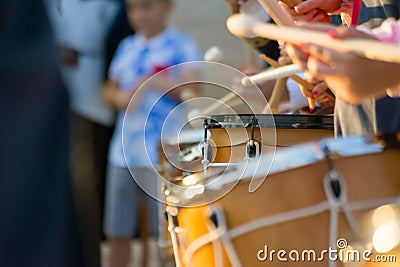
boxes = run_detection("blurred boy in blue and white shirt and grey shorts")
[104,0,202,267]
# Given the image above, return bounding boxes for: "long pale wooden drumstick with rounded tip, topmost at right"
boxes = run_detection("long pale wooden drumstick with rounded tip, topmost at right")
[227,14,400,63]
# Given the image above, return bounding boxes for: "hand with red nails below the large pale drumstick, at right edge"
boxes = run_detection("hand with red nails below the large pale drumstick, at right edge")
[288,26,400,103]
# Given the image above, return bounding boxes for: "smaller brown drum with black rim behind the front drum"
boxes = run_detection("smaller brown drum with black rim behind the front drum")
[207,114,333,162]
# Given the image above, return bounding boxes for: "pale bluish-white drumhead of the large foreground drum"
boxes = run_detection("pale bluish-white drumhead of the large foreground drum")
[167,136,382,206]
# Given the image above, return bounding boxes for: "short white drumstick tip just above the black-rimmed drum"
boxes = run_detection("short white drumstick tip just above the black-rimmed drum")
[242,64,300,86]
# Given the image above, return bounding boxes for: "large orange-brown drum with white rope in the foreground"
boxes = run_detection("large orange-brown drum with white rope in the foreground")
[166,137,400,267]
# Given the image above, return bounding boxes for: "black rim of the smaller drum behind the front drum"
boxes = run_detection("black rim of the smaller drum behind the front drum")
[207,114,334,130]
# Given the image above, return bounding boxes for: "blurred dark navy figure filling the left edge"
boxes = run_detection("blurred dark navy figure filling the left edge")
[0,0,84,267]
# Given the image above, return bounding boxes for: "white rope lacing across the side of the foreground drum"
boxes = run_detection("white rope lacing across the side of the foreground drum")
[183,196,400,267]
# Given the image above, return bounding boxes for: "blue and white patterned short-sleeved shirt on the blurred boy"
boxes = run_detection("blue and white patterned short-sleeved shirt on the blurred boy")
[109,28,201,168]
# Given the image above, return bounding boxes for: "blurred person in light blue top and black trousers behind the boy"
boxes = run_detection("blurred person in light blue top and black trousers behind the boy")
[48,0,121,267]
